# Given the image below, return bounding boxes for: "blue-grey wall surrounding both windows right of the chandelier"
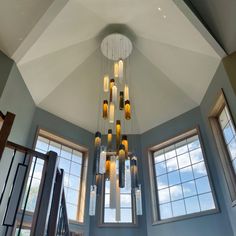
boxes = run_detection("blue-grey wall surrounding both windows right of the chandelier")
[141,60,236,236]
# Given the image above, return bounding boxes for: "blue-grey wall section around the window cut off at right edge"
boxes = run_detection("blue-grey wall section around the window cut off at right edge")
[200,63,236,235]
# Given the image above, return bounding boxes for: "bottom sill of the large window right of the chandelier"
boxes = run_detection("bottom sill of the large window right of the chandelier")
[152,208,220,226]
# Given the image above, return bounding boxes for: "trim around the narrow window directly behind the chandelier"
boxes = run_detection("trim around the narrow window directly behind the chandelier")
[97,171,138,228]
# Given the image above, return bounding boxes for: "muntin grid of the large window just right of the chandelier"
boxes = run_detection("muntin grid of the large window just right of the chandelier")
[153,134,216,221]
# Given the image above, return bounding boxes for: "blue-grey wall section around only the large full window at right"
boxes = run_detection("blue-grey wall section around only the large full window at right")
[141,108,233,236]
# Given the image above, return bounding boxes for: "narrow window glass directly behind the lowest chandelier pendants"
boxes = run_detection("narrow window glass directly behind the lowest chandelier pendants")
[103,160,134,224]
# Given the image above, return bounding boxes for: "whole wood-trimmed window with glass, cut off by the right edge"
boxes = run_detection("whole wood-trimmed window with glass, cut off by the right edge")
[209,91,236,205]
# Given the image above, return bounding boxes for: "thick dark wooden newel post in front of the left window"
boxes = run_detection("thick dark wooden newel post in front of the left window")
[30,151,59,236]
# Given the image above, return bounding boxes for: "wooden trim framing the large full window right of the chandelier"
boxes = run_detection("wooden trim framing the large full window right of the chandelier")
[148,126,220,225]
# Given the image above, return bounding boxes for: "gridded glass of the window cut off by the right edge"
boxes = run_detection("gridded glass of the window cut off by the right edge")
[218,105,236,174]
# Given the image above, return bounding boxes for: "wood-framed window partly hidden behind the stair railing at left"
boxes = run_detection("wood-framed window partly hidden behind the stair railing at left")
[24,130,87,223]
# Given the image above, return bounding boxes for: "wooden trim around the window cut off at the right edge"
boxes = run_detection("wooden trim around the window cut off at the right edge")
[208,89,236,207]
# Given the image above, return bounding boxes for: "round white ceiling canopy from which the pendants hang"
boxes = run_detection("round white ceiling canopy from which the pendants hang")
[101,33,133,61]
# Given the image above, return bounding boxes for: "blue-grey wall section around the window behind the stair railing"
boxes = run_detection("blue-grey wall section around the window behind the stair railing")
[29,108,94,236]
